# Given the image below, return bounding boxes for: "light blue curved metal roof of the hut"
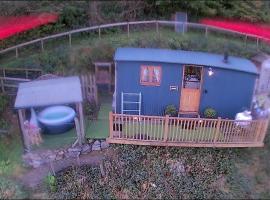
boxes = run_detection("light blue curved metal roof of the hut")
[114,48,258,74]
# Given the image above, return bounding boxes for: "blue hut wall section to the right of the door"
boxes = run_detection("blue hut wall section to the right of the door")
[200,68,256,118]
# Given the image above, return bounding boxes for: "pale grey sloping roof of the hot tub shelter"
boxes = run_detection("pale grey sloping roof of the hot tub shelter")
[15,76,83,109]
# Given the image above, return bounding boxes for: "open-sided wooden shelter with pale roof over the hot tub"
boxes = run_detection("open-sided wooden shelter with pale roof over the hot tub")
[15,76,85,152]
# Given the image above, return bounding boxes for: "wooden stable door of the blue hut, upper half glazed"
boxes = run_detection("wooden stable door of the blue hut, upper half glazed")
[179,66,202,112]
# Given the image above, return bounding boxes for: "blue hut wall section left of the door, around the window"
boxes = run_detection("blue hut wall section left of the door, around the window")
[116,61,182,115]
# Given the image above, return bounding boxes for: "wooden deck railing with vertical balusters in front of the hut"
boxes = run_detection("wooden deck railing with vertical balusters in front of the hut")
[108,113,268,147]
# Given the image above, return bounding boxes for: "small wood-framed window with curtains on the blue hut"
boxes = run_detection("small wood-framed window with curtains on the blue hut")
[140,66,161,86]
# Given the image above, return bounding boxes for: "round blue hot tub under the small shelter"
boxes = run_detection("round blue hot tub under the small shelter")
[38,106,76,134]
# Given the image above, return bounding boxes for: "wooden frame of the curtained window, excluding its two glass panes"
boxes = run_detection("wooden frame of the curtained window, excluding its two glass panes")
[140,65,162,86]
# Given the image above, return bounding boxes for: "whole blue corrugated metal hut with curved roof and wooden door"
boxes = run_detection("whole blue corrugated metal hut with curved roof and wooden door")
[114,48,258,118]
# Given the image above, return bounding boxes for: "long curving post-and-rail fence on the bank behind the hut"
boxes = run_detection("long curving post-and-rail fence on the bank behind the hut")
[0,20,270,58]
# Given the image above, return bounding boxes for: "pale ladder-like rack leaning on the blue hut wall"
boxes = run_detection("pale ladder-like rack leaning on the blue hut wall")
[121,92,142,115]
